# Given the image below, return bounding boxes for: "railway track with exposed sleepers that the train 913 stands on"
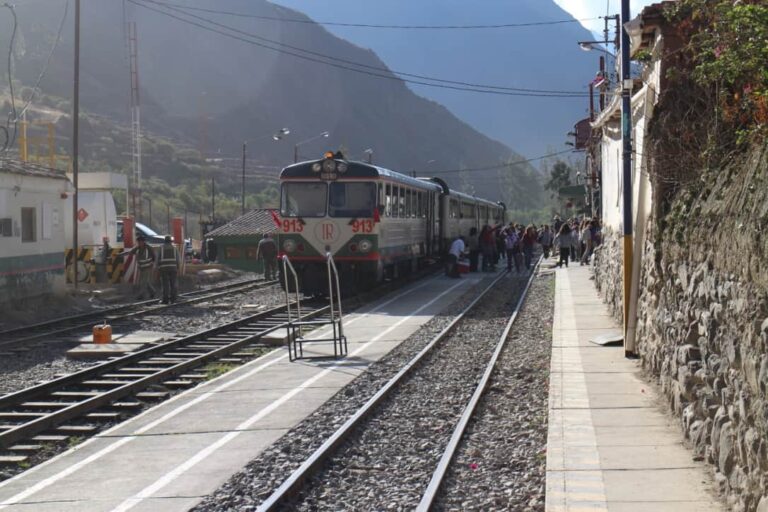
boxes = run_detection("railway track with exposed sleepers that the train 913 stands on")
[0,302,328,464]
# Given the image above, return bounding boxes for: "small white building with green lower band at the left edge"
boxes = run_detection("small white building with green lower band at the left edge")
[0,159,73,302]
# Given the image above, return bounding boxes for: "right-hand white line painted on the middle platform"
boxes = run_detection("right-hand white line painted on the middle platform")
[112,282,463,512]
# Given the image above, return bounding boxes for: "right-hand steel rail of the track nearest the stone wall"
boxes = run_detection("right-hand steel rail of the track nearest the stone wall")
[416,258,541,512]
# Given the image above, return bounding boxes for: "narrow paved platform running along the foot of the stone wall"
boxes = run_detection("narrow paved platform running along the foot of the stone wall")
[546,266,723,512]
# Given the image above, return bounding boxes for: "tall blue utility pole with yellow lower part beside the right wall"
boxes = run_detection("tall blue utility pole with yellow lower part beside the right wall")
[620,0,635,356]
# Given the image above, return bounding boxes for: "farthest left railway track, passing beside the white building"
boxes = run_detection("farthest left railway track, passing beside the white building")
[0,279,277,351]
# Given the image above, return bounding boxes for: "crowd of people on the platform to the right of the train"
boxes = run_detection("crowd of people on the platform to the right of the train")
[445,215,601,278]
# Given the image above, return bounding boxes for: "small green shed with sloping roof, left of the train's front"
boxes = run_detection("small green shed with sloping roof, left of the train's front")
[205,208,277,273]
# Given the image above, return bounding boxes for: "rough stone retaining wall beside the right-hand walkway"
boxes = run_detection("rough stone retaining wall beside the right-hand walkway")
[632,145,768,511]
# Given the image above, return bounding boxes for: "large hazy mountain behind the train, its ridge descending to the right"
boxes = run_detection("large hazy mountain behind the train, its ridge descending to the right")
[0,0,543,208]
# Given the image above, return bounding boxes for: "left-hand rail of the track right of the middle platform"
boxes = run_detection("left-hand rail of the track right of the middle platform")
[257,272,507,512]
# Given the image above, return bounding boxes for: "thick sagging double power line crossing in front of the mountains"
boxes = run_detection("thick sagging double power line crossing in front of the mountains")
[128,0,589,98]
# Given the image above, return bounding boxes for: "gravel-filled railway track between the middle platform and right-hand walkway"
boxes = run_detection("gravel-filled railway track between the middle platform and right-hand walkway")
[258,262,536,512]
